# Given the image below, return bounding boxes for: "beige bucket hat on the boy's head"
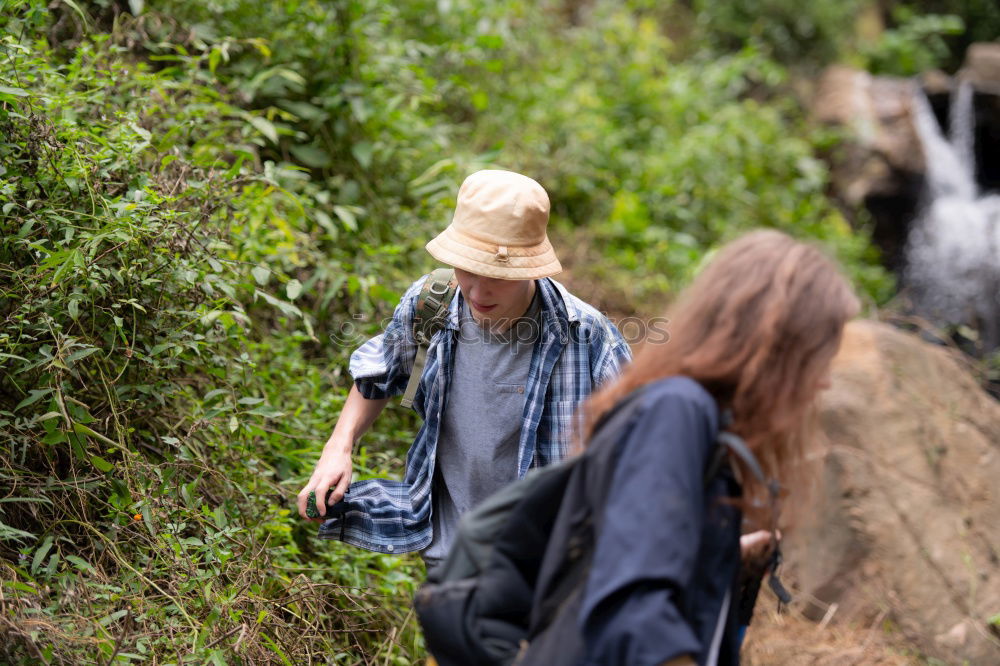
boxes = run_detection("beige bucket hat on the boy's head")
[427,169,562,280]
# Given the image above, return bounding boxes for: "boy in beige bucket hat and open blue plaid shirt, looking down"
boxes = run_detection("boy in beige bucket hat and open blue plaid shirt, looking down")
[298,170,630,568]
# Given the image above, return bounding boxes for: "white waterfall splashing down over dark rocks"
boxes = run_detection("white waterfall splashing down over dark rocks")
[904,82,1000,351]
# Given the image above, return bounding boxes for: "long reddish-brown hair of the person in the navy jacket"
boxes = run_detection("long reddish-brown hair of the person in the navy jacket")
[581,231,859,522]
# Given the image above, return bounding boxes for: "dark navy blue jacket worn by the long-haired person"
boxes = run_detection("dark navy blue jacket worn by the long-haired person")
[579,377,741,666]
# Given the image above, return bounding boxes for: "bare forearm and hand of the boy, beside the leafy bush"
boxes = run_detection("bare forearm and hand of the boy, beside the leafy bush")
[298,386,391,520]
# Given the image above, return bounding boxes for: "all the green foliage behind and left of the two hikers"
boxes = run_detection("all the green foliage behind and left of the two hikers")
[0,0,1000,664]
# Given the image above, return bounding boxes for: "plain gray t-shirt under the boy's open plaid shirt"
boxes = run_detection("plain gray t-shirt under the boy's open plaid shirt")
[423,291,541,570]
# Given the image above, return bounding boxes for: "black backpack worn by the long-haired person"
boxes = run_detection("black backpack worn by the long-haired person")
[414,389,777,666]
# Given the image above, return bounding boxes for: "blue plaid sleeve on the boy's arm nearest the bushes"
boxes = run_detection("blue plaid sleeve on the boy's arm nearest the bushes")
[350,275,427,400]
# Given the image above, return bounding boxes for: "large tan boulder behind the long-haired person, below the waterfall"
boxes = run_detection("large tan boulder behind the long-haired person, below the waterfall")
[786,322,1000,664]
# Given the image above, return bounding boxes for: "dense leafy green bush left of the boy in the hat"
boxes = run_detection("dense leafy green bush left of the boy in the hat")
[0,7,422,663]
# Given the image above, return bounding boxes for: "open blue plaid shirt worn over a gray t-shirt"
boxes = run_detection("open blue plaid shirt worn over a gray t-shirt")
[319,276,631,553]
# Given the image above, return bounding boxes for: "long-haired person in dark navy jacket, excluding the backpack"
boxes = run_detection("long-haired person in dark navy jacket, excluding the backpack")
[577,231,859,666]
